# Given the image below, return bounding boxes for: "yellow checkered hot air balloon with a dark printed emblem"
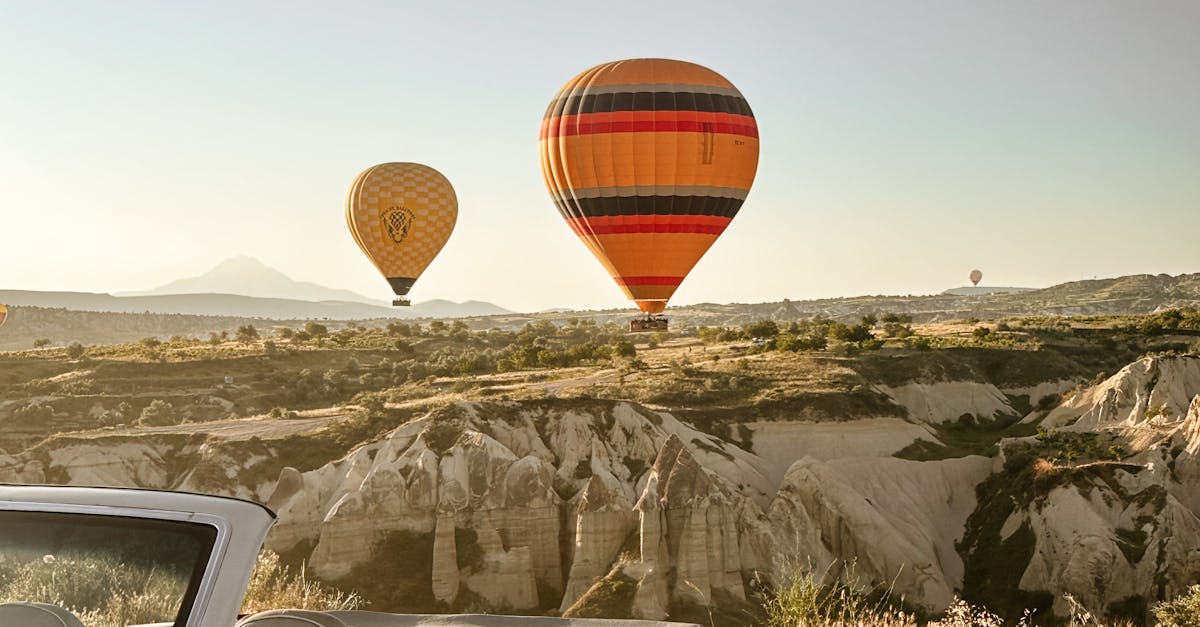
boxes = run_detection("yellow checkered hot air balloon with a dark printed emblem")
[346,163,458,305]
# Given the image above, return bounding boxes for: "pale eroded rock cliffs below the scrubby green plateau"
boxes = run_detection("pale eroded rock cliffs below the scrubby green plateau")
[7,357,1200,619]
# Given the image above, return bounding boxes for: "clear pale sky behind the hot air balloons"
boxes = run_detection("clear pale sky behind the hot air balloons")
[0,0,1200,311]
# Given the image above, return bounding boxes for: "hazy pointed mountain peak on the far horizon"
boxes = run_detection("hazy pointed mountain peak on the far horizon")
[115,256,383,305]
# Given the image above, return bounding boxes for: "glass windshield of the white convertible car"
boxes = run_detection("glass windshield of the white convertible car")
[0,510,216,627]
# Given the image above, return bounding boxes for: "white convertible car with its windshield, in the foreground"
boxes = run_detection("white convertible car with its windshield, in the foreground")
[0,485,696,627]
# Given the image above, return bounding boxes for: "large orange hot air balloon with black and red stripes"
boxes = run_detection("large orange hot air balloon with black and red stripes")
[538,59,758,330]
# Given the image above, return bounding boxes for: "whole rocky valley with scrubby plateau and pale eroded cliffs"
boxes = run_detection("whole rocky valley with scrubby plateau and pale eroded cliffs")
[0,303,1200,625]
